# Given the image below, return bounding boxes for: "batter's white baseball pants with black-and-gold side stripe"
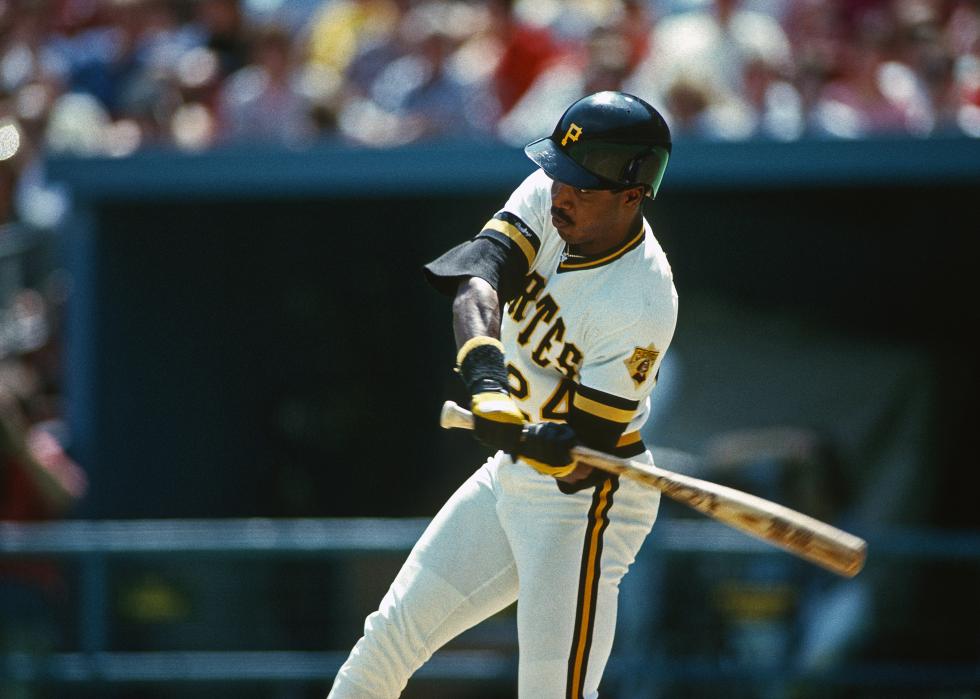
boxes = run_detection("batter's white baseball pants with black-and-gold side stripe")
[328,453,660,699]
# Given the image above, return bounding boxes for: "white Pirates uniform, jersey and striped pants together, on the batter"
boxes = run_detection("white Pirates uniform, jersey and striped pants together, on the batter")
[330,171,677,699]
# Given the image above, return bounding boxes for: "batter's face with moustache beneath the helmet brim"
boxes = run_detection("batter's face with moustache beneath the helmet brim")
[551,182,643,255]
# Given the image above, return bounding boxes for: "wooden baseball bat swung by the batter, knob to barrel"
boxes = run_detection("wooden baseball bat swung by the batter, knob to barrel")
[439,401,868,578]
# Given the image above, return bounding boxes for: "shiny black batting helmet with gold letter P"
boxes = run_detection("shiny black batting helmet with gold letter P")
[524,92,670,198]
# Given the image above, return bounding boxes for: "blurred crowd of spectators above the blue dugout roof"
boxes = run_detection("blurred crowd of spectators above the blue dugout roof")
[0,0,980,227]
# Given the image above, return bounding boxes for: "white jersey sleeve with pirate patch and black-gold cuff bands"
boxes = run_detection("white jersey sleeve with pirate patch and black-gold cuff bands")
[568,312,676,456]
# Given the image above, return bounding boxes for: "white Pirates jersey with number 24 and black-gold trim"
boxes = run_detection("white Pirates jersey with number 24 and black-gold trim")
[494,170,677,452]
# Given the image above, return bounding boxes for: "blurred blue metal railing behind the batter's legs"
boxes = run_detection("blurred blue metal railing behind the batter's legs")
[0,518,980,687]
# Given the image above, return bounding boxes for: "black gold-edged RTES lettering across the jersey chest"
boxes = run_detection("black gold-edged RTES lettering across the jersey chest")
[507,272,582,380]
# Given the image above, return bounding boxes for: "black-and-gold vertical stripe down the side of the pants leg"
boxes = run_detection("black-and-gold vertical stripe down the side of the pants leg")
[565,478,619,699]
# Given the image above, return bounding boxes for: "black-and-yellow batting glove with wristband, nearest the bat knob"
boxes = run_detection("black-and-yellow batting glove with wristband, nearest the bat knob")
[456,336,524,453]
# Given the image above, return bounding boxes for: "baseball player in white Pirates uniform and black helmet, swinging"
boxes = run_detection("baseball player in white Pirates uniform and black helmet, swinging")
[330,92,677,699]
